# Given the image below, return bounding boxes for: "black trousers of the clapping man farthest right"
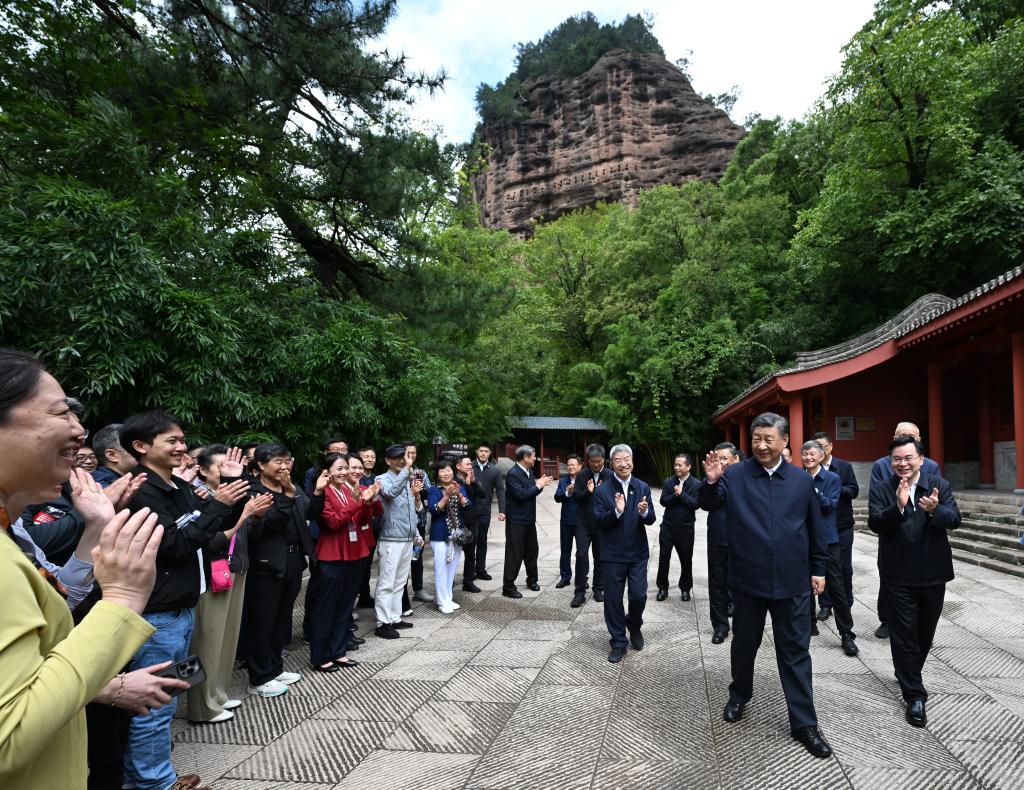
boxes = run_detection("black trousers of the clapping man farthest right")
[882,582,946,702]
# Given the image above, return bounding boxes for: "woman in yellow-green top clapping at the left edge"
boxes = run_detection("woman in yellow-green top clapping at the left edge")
[0,348,164,790]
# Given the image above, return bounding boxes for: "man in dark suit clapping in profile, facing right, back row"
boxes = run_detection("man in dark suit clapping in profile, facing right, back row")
[502,445,554,598]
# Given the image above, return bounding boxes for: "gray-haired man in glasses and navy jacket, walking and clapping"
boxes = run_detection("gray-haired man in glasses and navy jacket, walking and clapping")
[593,445,655,664]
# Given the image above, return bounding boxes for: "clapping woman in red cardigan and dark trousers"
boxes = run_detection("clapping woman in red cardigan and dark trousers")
[308,453,383,672]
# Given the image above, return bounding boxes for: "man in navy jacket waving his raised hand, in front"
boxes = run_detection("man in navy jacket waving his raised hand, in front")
[697,412,831,757]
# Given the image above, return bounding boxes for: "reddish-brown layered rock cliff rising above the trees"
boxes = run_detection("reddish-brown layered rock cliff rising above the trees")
[474,49,744,235]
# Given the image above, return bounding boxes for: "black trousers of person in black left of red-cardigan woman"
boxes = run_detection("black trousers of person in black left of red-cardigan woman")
[246,553,303,685]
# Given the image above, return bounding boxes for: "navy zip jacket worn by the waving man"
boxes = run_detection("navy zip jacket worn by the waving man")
[697,458,828,599]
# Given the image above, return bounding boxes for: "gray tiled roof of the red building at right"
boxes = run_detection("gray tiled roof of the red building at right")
[712,266,1024,419]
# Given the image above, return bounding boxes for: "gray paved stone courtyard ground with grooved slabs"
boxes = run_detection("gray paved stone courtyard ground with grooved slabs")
[174,494,1024,790]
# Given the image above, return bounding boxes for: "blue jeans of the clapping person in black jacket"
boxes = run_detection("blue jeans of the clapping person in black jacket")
[124,609,196,790]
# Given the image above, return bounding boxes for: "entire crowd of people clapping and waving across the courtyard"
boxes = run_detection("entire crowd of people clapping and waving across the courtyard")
[0,349,959,790]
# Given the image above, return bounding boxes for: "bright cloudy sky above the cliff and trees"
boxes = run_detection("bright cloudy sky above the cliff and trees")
[380,0,873,142]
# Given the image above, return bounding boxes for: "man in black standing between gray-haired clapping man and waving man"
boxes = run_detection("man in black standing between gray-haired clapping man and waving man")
[656,453,700,600]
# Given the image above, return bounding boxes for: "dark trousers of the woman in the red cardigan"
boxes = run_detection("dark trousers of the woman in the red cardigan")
[309,557,370,666]
